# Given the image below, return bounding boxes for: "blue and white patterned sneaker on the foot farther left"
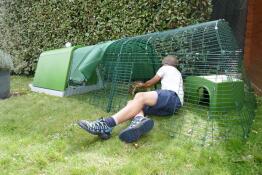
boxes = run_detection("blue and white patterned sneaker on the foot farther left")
[77,118,113,139]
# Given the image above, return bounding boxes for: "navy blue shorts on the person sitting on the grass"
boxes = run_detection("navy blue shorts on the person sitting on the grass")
[143,90,181,116]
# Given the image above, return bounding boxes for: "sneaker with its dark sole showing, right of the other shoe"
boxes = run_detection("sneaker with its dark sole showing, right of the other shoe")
[119,117,154,143]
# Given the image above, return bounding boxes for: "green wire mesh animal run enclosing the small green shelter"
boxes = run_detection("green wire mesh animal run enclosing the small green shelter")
[88,20,256,143]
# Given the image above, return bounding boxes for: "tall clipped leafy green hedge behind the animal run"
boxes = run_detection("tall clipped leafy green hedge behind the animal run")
[0,0,212,74]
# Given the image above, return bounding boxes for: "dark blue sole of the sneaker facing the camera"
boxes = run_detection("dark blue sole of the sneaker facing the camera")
[119,119,154,143]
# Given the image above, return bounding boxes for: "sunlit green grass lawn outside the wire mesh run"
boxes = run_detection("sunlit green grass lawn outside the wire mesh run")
[0,77,262,175]
